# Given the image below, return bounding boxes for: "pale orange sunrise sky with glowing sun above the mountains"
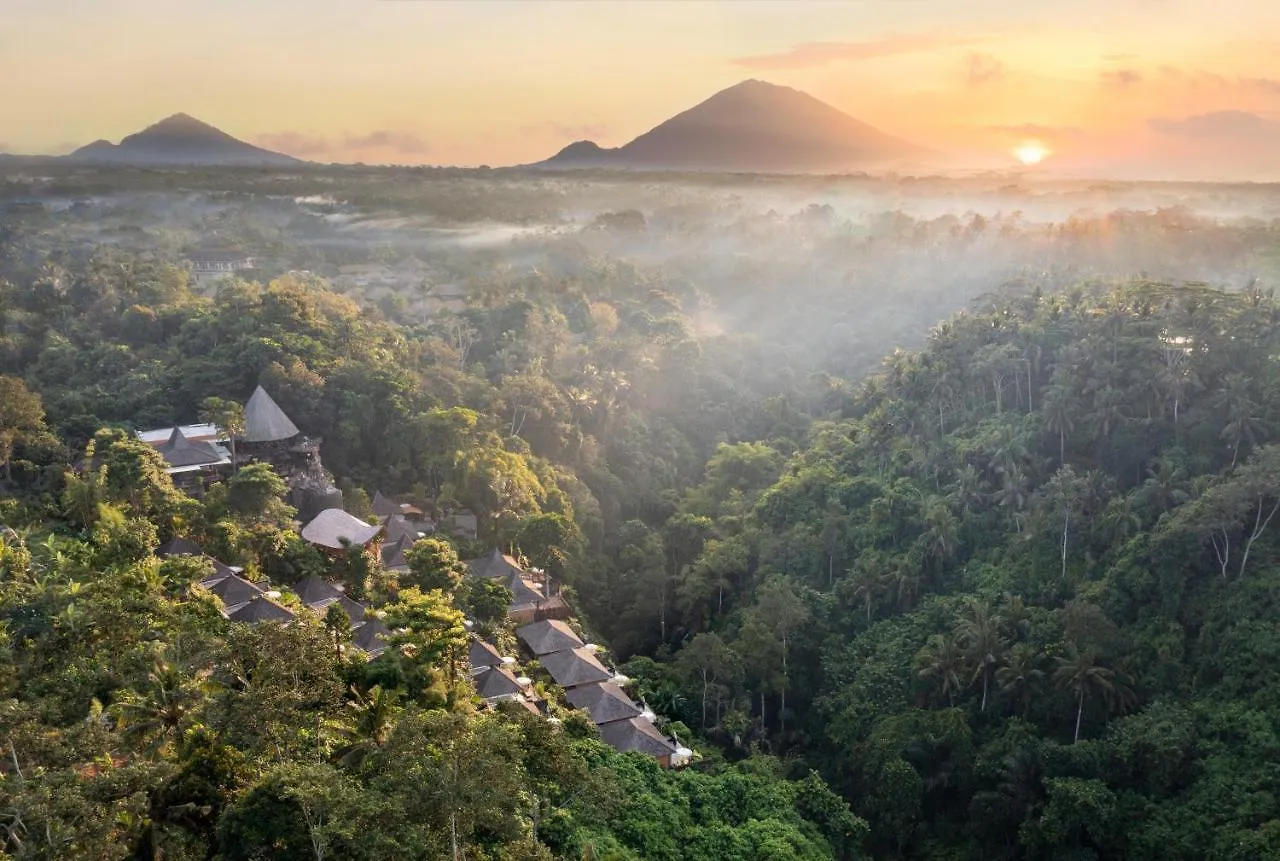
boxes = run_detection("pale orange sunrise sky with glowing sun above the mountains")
[0,0,1280,179]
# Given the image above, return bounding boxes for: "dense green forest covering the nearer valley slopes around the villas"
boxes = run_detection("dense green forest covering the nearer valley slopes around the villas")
[0,166,1280,861]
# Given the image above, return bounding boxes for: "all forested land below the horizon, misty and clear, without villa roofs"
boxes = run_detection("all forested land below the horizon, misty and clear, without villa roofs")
[0,162,1280,861]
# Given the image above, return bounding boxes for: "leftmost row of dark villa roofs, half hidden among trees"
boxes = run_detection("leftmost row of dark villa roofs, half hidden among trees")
[156,539,390,658]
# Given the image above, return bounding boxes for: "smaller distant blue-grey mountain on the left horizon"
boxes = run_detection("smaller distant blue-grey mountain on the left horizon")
[67,114,301,166]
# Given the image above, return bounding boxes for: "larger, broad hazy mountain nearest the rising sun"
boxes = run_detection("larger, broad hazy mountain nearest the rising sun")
[534,81,929,173]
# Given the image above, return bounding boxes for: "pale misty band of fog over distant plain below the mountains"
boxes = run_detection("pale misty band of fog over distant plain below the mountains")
[0,170,1280,374]
